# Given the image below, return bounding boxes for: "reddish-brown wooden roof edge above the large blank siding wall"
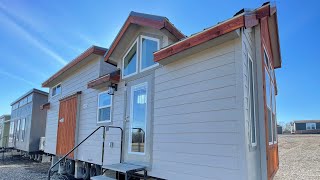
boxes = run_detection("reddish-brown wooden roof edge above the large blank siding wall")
[154,3,281,68]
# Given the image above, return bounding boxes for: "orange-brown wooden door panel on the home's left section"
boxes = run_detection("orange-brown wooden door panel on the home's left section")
[56,95,78,158]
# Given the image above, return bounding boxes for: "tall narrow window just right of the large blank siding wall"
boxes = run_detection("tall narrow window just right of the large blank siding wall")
[248,56,257,146]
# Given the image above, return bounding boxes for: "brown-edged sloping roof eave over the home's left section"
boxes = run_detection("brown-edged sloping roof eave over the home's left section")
[42,46,107,87]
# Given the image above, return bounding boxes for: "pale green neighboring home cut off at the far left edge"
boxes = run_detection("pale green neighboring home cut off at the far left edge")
[0,115,10,148]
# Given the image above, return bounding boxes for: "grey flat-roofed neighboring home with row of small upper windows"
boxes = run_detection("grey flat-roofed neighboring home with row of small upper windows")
[9,89,48,154]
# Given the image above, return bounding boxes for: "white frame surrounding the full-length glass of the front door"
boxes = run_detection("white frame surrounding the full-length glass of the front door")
[128,82,148,155]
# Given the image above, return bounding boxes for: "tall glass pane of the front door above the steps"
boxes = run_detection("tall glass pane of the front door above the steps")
[130,84,147,153]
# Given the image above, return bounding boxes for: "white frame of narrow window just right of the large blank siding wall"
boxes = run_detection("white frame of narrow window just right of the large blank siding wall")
[247,53,257,147]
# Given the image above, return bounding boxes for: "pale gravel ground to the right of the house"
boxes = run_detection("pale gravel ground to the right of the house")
[274,135,320,180]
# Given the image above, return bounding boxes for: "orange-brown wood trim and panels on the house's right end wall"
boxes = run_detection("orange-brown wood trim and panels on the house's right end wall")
[260,17,279,179]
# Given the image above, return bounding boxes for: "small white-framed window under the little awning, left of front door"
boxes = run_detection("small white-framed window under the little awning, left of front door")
[97,91,112,123]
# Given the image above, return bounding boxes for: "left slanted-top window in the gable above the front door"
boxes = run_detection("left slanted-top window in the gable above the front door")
[123,41,138,76]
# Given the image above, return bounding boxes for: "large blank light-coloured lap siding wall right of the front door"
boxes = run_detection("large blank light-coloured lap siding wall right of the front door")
[149,39,245,180]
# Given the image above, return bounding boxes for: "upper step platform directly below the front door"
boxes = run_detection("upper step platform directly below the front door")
[102,163,146,173]
